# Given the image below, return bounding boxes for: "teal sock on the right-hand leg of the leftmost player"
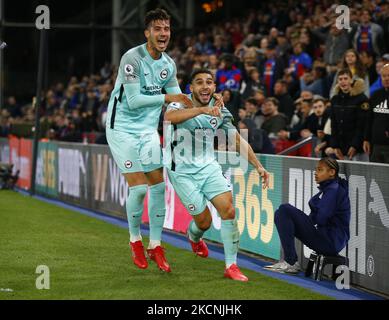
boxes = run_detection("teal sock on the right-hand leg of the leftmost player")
[149,182,166,241]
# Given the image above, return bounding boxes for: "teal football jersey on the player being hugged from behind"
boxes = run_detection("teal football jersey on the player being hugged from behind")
[164,96,236,173]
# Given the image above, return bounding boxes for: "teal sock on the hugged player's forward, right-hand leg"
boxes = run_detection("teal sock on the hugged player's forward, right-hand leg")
[220,219,239,267]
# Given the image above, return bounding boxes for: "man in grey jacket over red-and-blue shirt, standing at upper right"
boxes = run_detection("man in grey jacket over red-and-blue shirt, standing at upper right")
[353,9,384,56]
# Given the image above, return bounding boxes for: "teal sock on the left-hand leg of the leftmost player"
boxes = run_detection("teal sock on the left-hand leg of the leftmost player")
[126,184,147,237]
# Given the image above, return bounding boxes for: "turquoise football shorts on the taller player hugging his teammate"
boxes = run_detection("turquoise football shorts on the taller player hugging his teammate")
[106,128,163,173]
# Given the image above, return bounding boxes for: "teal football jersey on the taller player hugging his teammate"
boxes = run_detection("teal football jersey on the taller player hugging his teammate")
[106,44,181,134]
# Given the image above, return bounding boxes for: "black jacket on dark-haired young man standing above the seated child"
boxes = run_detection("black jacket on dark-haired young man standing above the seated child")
[330,79,369,154]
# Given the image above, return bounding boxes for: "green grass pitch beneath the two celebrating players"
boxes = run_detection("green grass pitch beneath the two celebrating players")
[0,191,329,300]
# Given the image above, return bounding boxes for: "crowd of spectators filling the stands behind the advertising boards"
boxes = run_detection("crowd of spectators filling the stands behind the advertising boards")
[0,0,389,162]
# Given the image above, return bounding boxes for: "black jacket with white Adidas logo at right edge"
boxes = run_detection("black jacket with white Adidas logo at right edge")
[366,88,389,145]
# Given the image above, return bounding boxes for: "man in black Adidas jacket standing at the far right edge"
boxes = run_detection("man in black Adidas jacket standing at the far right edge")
[363,63,389,163]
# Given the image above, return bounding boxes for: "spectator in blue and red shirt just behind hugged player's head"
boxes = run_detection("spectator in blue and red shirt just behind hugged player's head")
[216,54,242,91]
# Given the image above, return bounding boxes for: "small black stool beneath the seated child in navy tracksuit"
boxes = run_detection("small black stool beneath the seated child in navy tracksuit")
[305,252,349,281]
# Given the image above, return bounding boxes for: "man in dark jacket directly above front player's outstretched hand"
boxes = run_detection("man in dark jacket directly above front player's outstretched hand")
[260,98,288,138]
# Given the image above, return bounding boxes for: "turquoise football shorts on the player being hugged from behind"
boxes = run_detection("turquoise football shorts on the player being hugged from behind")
[167,162,231,216]
